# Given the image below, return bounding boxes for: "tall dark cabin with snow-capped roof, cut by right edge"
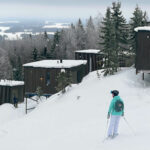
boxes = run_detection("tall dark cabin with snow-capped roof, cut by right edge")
[135,26,150,75]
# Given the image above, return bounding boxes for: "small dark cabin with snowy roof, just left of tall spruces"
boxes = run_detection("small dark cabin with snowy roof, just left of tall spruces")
[75,49,104,72]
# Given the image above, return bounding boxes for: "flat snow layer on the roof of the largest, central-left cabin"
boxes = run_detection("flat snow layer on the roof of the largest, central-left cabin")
[23,60,87,68]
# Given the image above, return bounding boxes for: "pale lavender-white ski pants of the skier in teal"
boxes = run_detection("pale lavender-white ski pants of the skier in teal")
[107,115,121,136]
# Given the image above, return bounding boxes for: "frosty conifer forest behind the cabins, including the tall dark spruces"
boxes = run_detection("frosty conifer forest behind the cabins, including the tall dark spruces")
[0,2,149,80]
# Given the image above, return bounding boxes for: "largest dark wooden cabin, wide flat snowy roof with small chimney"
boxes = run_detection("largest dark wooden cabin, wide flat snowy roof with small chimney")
[23,60,87,95]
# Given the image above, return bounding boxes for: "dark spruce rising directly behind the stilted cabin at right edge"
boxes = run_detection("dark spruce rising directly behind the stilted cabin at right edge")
[129,5,148,53]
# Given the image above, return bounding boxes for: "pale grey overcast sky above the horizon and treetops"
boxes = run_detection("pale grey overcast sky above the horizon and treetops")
[0,0,150,19]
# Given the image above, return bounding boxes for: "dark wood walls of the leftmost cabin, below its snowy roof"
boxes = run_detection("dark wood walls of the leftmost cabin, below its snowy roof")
[0,85,24,104]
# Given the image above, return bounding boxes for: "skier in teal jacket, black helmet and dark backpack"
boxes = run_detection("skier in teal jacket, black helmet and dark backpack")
[107,90,124,138]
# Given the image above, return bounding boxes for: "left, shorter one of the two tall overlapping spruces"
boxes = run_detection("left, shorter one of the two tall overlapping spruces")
[100,7,115,75]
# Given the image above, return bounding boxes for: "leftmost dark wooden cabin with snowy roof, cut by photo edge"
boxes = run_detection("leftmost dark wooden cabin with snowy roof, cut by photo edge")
[0,80,24,104]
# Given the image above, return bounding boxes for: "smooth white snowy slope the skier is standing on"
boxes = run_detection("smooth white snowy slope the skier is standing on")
[0,68,150,150]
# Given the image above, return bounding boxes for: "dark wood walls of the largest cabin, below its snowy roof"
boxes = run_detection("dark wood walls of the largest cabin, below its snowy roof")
[24,65,86,95]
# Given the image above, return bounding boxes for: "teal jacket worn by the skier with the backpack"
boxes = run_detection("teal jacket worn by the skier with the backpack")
[108,96,124,116]
